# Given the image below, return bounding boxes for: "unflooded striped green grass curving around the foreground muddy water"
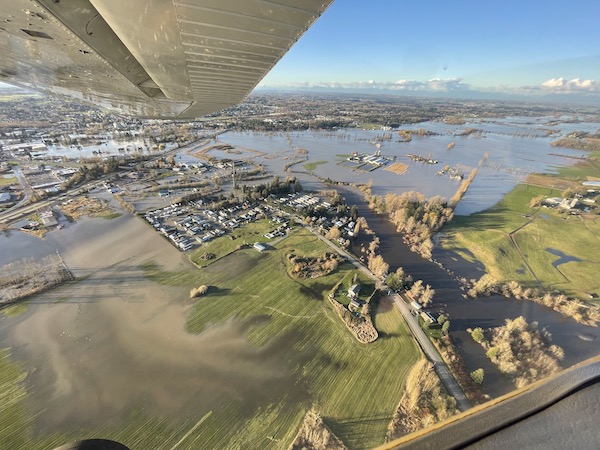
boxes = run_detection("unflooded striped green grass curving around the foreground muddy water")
[0,230,419,449]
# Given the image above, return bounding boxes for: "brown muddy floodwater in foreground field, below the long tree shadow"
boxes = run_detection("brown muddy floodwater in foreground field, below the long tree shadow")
[3,294,300,430]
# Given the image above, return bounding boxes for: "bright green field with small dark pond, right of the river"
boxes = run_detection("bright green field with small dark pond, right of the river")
[442,184,600,299]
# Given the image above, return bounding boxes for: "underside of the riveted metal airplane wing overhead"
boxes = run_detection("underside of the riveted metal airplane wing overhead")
[0,0,333,119]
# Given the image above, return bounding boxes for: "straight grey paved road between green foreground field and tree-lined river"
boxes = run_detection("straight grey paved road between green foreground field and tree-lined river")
[308,221,471,411]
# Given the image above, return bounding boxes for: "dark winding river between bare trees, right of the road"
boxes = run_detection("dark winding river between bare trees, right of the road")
[343,186,600,396]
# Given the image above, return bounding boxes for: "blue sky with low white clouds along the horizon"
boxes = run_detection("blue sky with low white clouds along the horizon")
[260,0,600,98]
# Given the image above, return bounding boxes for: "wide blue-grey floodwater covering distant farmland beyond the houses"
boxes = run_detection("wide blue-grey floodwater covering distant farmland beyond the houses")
[219,117,600,215]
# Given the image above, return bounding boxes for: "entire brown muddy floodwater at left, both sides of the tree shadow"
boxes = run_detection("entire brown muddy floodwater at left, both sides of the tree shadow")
[0,215,306,433]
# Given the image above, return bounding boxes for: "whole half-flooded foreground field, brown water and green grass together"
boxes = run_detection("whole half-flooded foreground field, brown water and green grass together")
[0,210,419,449]
